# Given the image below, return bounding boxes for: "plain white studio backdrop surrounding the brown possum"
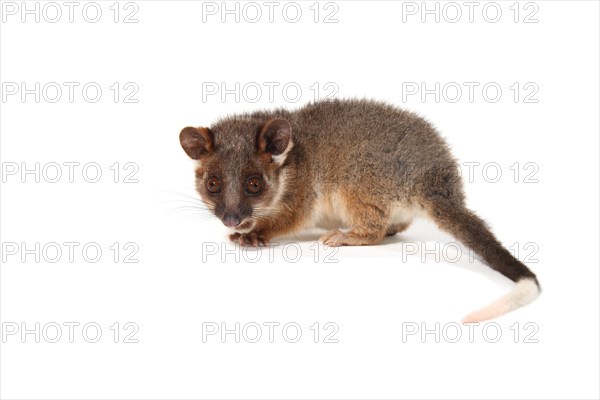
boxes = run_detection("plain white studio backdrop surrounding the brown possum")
[0,1,600,399]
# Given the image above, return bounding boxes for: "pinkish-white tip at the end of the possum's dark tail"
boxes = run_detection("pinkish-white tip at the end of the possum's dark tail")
[462,278,540,323]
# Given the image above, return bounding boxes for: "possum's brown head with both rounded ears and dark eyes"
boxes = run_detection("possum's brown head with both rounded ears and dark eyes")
[179,118,293,232]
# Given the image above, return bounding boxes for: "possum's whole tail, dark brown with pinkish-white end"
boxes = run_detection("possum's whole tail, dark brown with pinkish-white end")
[426,196,540,322]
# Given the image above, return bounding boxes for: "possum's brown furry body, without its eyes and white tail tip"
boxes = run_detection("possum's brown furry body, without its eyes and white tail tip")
[180,100,535,288]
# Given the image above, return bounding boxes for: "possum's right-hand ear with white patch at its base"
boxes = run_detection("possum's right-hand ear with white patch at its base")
[257,118,293,165]
